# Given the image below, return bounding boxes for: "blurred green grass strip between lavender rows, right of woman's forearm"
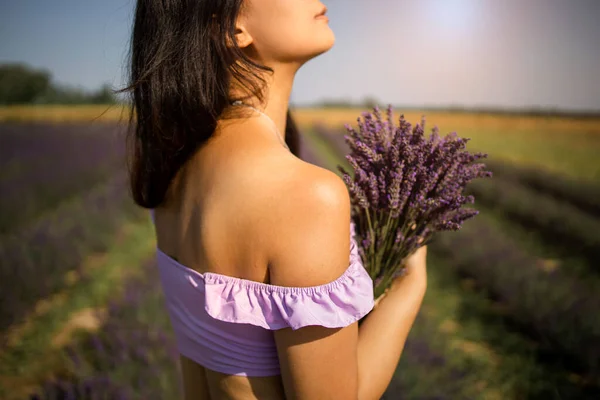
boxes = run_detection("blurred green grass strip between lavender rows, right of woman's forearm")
[422,255,596,399]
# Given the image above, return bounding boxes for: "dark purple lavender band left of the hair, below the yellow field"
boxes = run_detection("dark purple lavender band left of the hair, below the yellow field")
[0,124,124,235]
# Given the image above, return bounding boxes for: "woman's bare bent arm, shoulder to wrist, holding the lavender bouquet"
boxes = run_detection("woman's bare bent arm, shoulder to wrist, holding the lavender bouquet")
[268,163,425,400]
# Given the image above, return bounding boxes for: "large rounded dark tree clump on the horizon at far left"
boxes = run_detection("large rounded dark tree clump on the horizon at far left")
[0,63,50,104]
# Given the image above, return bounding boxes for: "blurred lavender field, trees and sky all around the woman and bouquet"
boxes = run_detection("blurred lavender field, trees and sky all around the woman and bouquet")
[0,0,600,399]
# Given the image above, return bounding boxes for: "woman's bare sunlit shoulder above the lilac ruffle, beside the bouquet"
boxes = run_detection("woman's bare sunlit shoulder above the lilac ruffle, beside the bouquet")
[267,156,350,287]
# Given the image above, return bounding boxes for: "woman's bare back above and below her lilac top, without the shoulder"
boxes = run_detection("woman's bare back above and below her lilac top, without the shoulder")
[154,119,293,399]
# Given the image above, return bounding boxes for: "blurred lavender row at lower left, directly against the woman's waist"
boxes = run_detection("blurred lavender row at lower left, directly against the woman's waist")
[56,257,181,400]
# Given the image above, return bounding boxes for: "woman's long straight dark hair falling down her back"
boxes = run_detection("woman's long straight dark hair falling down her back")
[119,0,299,208]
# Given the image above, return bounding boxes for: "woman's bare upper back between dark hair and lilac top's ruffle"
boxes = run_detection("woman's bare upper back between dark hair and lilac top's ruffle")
[156,116,286,281]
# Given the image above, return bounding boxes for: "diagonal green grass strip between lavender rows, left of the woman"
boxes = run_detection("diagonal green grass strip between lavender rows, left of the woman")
[0,217,154,398]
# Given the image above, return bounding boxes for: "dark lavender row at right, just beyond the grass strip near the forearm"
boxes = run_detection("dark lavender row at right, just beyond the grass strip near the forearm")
[431,215,600,374]
